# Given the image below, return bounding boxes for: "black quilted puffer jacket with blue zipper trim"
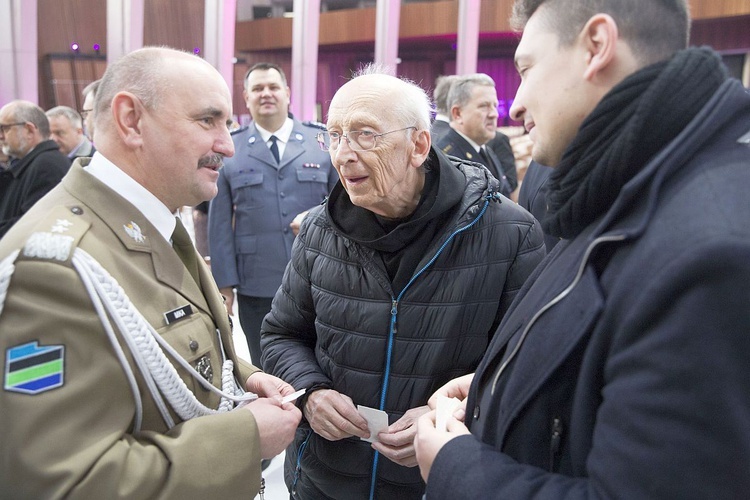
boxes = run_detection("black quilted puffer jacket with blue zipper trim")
[262,151,545,500]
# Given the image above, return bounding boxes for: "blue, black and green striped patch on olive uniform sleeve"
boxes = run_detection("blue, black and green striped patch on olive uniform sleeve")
[5,341,65,394]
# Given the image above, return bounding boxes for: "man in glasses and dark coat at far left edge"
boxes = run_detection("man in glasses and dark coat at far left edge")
[0,101,70,238]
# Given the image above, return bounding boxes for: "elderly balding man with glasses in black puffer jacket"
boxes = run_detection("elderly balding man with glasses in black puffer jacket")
[261,68,544,499]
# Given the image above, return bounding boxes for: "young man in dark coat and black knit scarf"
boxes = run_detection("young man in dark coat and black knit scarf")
[415,0,750,500]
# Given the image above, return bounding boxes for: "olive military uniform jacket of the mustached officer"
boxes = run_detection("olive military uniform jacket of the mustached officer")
[0,159,260,499]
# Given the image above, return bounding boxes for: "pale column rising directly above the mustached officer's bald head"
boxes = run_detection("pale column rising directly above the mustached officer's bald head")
[107,0,145,64]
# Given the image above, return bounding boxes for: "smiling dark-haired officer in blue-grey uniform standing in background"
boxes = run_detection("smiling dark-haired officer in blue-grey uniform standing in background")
[208,63,338,363]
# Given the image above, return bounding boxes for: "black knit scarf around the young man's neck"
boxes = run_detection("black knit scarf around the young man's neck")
[542,48,727,238]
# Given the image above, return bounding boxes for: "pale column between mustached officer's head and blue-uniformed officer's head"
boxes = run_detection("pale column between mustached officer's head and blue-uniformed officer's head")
[203,0,237,94]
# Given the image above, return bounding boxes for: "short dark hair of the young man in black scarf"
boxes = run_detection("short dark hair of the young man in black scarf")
[511,0,690,66]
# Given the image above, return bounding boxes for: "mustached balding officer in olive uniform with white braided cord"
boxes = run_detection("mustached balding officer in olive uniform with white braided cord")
[0,48,301,498]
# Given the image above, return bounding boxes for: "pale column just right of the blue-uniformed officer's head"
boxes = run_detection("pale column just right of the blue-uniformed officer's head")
[290,0,320,120]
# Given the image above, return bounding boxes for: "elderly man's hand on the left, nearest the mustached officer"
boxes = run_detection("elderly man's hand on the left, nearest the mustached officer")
[305,389,370,441]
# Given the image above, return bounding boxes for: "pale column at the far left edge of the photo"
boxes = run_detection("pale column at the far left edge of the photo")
[0,0,39,105]
